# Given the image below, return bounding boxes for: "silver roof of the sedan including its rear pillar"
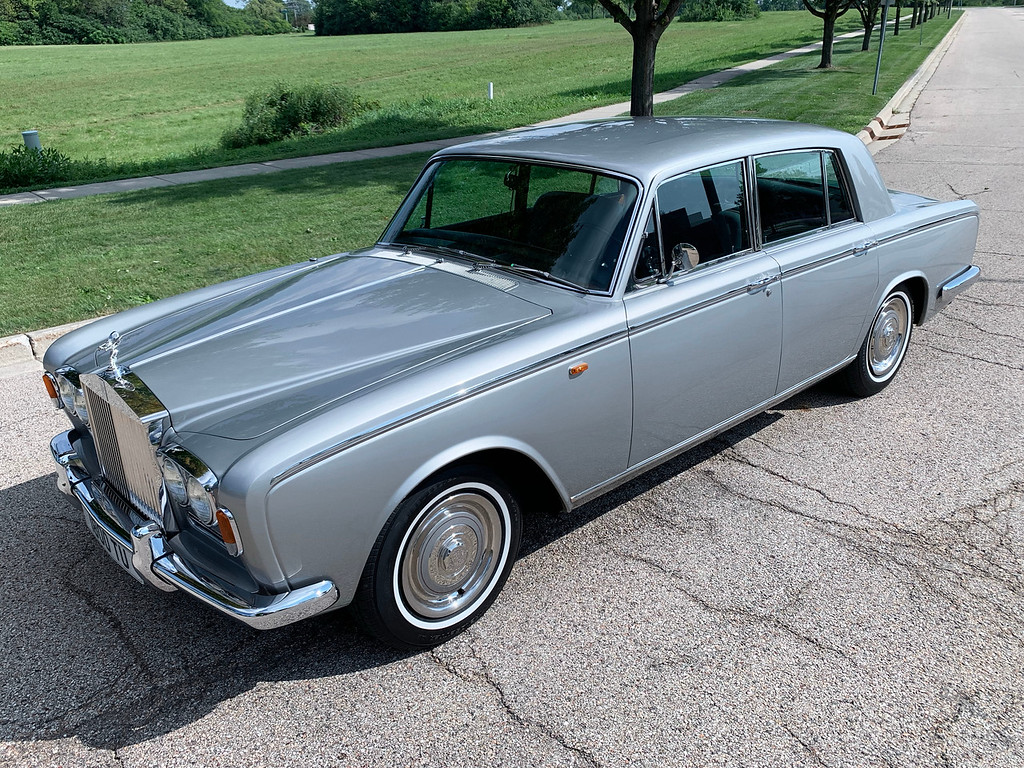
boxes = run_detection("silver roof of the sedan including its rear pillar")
[434,117,892,221]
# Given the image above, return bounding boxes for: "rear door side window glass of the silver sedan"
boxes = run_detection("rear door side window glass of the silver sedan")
[754,151,854,243]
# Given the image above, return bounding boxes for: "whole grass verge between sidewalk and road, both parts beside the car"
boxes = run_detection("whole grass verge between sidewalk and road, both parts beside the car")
[0,14,949,336]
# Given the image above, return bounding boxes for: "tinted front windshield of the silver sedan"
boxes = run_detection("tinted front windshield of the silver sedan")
[387,160,639,291]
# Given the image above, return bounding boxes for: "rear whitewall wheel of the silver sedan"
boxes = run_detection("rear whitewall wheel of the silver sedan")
[840,289,913,397]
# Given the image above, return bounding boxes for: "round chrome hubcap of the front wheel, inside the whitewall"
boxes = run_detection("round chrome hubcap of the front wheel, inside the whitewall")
[398,488,504,621]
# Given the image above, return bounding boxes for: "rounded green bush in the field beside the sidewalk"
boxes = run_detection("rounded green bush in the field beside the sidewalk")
[220,83,378,150]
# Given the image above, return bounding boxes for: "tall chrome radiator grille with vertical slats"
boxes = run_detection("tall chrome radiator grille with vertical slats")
[81,374,163,522]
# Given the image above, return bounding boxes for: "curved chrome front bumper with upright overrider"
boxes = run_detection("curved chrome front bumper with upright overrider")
[50,432,338,630]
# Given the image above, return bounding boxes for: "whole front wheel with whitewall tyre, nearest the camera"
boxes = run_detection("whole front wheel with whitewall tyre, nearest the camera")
[352,467,522,648]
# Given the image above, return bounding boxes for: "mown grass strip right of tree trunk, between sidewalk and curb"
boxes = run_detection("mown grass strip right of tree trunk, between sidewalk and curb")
[654,13,958,133]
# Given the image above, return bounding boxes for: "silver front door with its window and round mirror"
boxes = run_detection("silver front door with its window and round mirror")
[625,161,782,466]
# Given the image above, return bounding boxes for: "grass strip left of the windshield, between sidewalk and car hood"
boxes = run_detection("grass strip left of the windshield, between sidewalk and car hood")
[0,155,427,336]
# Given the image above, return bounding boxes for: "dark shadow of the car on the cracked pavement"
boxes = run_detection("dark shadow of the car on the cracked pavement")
[0,390,839,750]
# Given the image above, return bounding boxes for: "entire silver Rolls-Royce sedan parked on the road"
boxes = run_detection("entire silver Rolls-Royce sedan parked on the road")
[45,118,979,648]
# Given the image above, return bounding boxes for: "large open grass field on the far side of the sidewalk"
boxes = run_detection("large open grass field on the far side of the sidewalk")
[0,11,855,177]
